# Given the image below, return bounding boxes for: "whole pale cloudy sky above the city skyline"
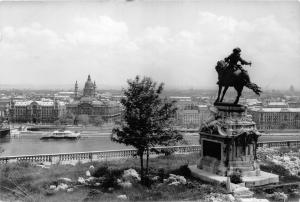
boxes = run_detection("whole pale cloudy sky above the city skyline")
[0,0,300,90]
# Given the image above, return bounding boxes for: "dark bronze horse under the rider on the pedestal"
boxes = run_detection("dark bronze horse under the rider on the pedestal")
[215,60,262,104]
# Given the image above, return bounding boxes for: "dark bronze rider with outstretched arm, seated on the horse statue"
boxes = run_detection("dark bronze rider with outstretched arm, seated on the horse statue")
[224,47,252,73]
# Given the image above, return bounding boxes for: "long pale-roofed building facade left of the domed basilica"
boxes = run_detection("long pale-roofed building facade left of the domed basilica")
[10,100,66,123]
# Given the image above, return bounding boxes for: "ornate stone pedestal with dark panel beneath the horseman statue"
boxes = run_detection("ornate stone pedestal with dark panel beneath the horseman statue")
[192,103,278,187]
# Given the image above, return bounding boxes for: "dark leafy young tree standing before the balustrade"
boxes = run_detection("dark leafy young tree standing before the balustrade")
[111,76,183,183]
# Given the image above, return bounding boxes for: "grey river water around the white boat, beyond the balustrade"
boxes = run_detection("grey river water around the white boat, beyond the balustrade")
[0,133,199,156]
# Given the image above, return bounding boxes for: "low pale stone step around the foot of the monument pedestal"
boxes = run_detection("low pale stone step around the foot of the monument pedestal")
[189,165,279,187]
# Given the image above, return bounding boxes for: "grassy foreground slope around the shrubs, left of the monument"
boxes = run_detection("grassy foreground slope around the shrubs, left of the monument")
[0,154,222,201]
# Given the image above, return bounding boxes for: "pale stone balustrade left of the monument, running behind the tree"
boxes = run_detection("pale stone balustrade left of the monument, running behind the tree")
[0,145,200,164]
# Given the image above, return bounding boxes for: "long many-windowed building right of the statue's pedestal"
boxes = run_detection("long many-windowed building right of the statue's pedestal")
[249,107,300,130]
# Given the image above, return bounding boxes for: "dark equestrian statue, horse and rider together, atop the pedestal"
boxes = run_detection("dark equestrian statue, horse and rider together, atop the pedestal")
[215,48,262,105]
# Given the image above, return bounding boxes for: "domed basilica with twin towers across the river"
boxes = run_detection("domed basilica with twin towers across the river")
[67,75,121,122]
